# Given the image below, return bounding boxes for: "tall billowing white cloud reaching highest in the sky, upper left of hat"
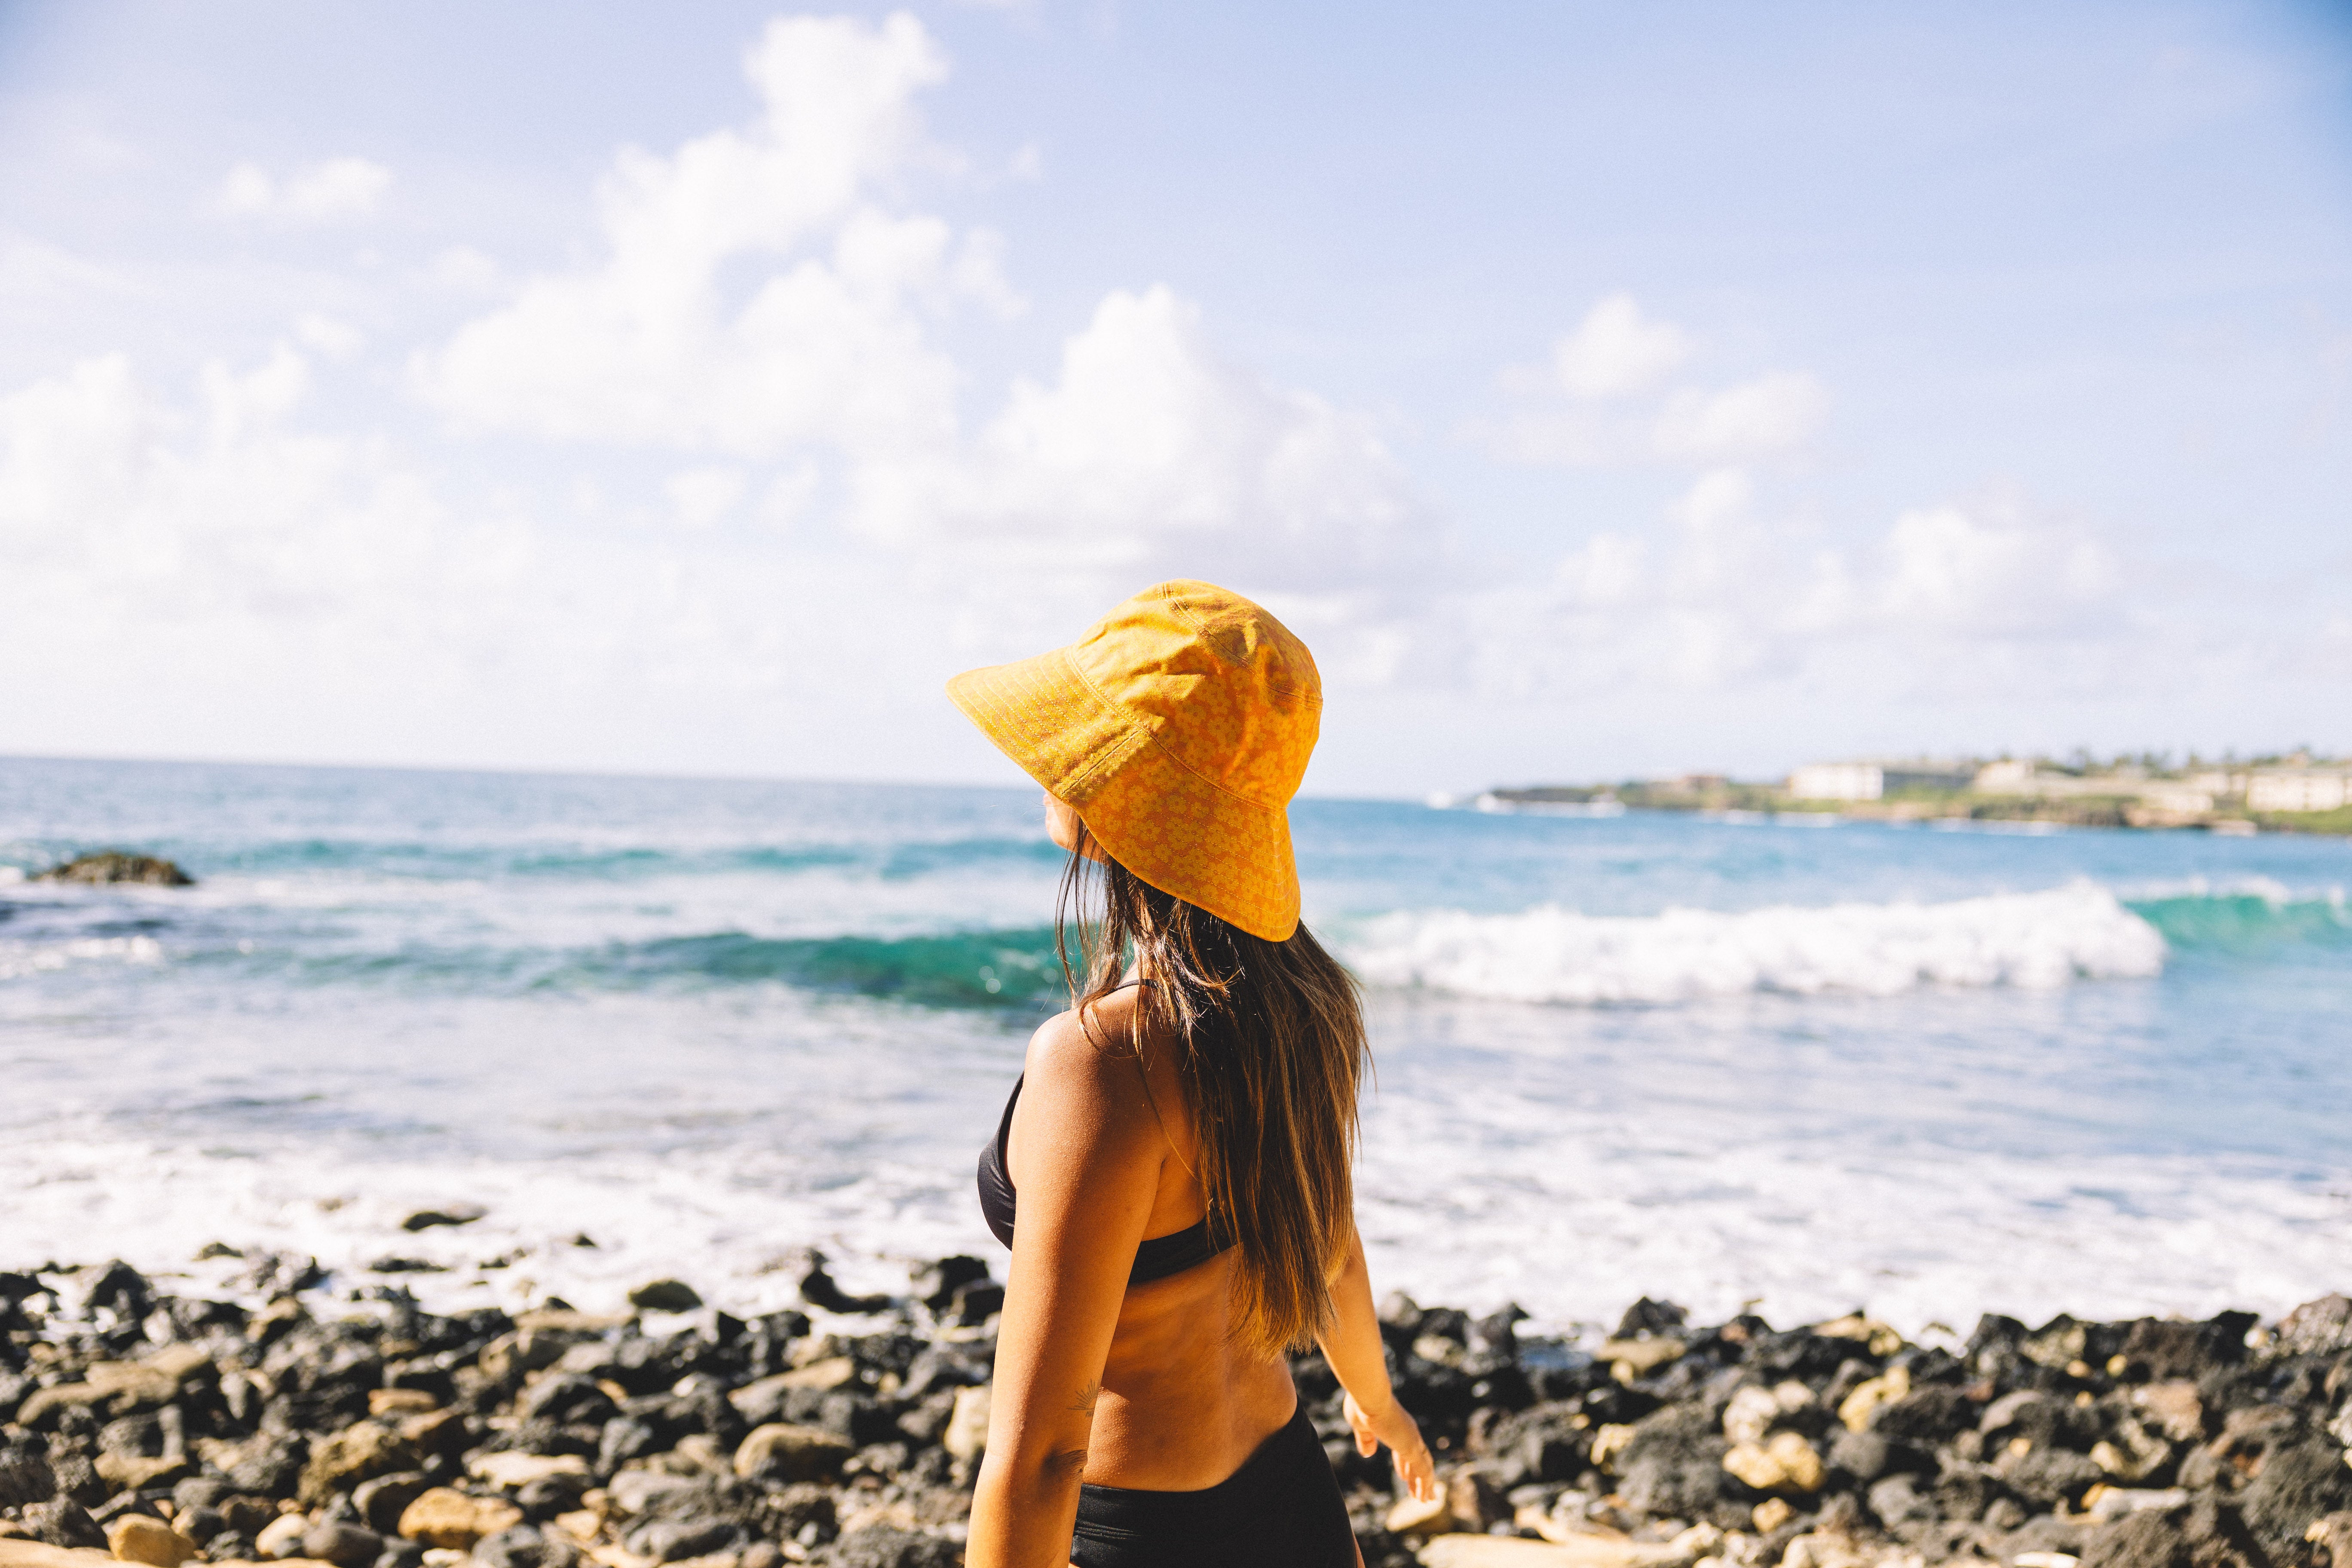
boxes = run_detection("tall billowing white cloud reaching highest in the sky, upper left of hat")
[416,14,974,459]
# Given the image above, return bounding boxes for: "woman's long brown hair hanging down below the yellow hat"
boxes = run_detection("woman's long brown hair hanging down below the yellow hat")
[1054,827,1366,1357]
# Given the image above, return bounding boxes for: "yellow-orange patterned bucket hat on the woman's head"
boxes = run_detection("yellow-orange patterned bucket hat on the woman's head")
[948,581,1322,943]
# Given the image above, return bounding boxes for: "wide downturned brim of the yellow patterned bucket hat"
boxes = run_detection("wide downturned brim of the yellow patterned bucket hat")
[948,649,1298,943]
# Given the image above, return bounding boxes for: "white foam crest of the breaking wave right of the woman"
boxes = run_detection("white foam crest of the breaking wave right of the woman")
[1341,882,2164,1004]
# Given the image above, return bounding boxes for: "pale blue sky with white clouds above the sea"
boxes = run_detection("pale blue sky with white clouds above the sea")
[0,0,2352,795]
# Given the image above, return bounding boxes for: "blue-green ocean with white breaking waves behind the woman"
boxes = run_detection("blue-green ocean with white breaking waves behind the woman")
[0,760,2352,1333]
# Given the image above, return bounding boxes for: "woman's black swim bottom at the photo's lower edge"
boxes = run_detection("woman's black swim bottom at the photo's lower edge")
[1070,1408,1355,1568]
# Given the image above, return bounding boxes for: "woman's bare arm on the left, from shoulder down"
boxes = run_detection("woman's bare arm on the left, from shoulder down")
[965,1013,1167,1568]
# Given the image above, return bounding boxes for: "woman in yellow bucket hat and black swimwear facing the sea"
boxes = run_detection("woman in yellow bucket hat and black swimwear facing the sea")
[948,583,1437,1568]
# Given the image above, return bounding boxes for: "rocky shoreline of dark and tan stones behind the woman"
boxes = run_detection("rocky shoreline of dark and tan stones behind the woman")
[0,1256,2352,1568]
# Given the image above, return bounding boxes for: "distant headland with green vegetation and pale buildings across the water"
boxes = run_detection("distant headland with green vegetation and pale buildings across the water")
[1477,750,2352,837]
